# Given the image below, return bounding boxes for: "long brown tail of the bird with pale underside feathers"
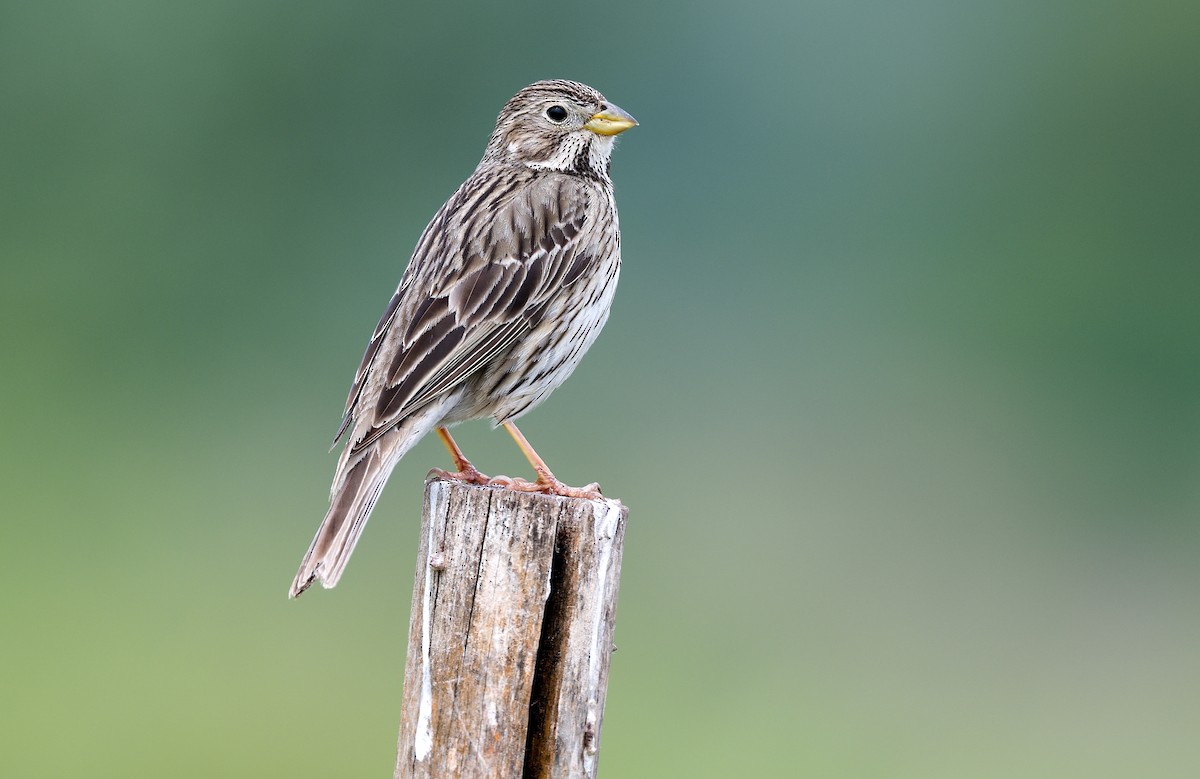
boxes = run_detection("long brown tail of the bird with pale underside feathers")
[288,403,451,598]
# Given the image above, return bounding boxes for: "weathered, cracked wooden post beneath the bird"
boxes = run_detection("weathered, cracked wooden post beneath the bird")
[395,480,628,779]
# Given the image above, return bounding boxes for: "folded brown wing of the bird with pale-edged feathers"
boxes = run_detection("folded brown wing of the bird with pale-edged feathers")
[335,170,595,450]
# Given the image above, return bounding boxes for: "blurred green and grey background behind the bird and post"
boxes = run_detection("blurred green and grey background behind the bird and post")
[0,0,1200,779]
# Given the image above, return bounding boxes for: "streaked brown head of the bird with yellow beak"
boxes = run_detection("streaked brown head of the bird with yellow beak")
[484,80,637,174]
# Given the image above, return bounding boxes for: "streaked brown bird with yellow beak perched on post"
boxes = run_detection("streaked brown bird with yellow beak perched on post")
[288,79,637,598]
